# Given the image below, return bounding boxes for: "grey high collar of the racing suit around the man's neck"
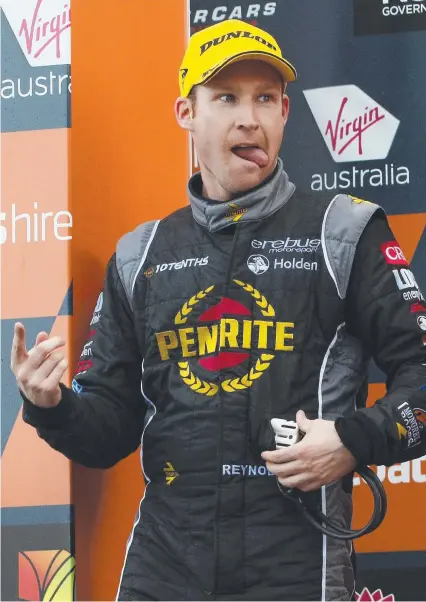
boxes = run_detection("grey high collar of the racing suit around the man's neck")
[187,158,296,232]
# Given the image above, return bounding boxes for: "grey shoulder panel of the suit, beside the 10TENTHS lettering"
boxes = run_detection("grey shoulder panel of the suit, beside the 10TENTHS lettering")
[115,220,160,307]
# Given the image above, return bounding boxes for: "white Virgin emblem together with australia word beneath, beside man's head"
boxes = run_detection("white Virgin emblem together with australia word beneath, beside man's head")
[304,85,410,190]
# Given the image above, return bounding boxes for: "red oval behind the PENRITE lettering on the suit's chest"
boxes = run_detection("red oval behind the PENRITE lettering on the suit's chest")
[198,297,252,370]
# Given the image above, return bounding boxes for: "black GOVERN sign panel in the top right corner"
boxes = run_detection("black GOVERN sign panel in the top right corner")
[354,0,426,36]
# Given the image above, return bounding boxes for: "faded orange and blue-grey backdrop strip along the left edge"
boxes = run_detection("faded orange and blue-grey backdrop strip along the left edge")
[0,0,75,600]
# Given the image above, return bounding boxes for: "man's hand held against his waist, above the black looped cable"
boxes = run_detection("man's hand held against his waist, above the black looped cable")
[262,410,356,491]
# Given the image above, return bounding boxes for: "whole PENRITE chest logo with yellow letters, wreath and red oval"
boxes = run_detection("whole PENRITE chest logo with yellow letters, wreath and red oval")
[155,280,294,397]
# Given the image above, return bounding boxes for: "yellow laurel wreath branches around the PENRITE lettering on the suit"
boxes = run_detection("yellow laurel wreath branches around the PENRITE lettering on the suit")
[175,280,275,397]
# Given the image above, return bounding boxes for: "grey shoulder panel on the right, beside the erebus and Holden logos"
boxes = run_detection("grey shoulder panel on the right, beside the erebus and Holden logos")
[321,194,383,299]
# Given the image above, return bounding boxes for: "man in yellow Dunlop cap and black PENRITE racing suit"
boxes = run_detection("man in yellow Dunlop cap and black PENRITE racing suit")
[12,20,426,600]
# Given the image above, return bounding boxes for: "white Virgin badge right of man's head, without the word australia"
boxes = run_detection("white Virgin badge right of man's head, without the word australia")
[304,85,399,163]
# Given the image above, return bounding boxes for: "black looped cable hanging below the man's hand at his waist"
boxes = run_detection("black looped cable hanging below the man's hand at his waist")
[277,466,387,540]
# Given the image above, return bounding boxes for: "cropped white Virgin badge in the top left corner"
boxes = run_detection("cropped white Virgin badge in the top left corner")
[2,0,71,67]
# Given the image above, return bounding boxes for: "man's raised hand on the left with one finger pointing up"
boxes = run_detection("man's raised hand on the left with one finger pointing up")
[10,322,68,408]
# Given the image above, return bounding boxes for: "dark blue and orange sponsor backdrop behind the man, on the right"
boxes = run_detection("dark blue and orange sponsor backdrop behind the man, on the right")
[189,0,426,601]
